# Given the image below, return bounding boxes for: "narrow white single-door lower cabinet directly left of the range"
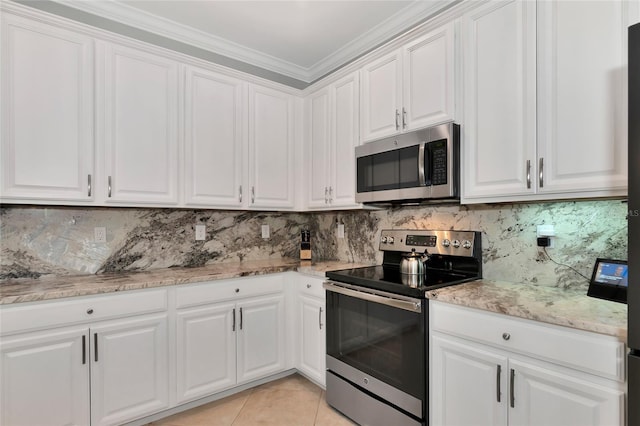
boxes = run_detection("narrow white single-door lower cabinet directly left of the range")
[296,276,326,386]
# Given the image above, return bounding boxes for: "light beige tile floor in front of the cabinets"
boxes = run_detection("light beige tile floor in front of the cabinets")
[148,374,355,426]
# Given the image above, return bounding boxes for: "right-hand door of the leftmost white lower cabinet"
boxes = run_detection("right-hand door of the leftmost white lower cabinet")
[91,314,169,426]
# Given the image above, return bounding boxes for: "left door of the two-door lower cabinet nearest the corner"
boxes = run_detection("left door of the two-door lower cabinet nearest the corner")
[176,304,236,403]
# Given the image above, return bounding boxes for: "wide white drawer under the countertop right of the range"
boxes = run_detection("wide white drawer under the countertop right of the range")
[430,302,625,381]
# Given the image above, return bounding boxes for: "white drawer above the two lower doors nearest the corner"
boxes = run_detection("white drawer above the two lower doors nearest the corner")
[176,275,284,308]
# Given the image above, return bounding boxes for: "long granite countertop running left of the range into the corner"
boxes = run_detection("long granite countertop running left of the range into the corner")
[0,259,369,305]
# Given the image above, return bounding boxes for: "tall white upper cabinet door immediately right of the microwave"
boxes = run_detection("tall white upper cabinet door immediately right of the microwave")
[462,0,536,202]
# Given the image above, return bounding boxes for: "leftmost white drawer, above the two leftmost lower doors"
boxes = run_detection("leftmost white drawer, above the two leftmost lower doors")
[0,289,167,334]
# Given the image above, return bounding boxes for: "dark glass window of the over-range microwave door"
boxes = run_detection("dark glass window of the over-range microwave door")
[357,145,420,193]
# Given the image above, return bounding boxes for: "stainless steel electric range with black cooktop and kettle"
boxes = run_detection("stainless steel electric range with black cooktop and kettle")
[324,230,482,426]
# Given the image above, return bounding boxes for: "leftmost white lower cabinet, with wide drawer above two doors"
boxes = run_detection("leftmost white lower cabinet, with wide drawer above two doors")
[0,291,169,426]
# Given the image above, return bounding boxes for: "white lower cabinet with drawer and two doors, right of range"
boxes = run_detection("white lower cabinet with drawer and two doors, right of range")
[430,301,625,426]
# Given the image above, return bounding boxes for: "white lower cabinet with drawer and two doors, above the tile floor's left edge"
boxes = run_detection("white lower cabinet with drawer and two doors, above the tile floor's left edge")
[176,275,287,403]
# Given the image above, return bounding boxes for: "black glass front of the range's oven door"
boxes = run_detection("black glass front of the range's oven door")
[327,292,426,399]
